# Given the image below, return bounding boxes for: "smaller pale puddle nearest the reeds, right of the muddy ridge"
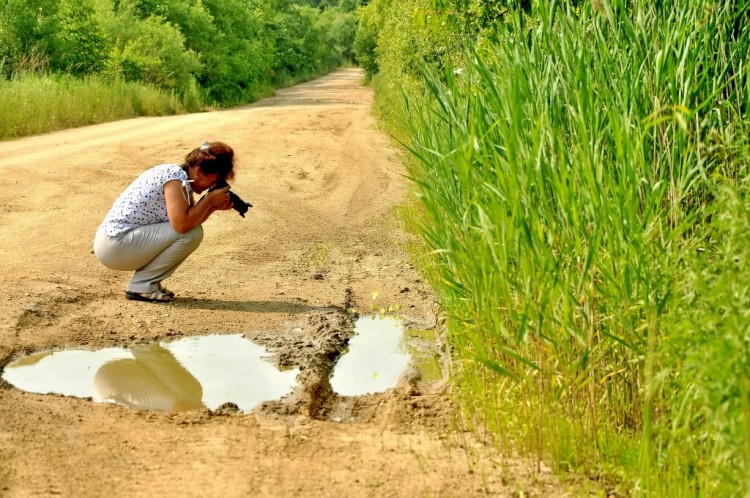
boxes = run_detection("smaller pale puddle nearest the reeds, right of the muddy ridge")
[331,317,411,396]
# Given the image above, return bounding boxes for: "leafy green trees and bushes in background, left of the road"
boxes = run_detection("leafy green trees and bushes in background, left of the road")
[0,0,358,113]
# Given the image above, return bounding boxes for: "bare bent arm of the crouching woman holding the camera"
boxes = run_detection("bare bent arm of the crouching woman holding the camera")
[164,180,232,233]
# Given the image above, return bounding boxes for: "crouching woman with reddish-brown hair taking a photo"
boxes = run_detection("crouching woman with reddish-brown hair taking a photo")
[94,142,234,302]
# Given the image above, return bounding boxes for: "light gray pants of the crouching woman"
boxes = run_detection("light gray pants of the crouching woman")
[94,223,203,292]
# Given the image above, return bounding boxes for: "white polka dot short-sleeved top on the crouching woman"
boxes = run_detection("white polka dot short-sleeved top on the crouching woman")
[99,164,188,237]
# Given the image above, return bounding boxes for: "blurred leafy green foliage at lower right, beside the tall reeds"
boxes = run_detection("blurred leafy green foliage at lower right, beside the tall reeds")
[643,128,750,497]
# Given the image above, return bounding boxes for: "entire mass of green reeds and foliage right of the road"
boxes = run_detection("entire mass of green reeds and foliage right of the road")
[368,0,750,496]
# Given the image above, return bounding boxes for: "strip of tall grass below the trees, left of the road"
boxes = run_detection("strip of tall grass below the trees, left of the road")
[0,74,201,139]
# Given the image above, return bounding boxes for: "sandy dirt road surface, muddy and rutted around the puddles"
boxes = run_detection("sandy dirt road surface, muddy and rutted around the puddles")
[0,69,564,497]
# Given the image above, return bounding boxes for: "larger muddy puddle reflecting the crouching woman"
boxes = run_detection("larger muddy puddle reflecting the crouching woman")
[3,334,299,411]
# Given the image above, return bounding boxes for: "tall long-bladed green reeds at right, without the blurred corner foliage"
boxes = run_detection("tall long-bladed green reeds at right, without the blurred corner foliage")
[402,1,750,489]
